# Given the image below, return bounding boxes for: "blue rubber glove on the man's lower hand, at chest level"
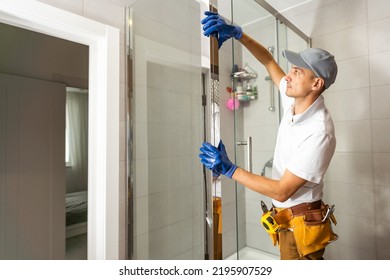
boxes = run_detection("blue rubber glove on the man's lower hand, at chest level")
[199,140,237,178]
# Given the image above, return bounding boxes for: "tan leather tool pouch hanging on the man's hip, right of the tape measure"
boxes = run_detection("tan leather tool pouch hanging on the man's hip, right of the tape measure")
[289,205,338,256]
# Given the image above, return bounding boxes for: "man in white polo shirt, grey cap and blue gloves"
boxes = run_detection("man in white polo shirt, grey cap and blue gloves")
[200,12,337,259]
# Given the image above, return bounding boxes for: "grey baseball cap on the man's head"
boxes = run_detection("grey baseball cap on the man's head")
[282,48,337,88]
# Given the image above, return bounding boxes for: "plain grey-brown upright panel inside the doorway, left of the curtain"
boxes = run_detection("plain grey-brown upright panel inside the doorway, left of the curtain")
[0,74,65,260]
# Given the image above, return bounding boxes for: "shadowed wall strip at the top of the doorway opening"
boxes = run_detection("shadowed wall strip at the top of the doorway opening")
[0,24,88,88]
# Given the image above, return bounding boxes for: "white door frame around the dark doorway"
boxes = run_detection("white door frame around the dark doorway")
[0,0,120,259]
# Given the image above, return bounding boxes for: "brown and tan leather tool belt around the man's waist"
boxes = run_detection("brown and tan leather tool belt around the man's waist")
[269,200,338,256]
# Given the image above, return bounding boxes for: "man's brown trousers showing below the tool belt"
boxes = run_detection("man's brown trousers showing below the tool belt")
[279,231,325,260]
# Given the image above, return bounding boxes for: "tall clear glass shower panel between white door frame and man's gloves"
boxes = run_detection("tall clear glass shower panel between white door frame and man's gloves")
[128,0,205,259]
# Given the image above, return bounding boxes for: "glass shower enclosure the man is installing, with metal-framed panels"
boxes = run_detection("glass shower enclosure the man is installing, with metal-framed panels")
[127,0,309,259]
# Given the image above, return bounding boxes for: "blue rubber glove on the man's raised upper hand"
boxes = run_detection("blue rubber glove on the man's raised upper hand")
[201,11,242,48]
